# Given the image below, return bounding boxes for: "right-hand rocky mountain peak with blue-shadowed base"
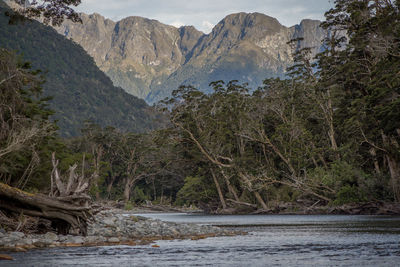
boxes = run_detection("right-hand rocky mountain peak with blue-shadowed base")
[146,13,325,102]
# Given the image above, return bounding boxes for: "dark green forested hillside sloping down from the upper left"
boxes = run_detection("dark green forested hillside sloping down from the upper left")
[0,2,164,136]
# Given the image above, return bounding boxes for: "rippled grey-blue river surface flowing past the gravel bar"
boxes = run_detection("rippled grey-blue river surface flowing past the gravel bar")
[0,213,400,267]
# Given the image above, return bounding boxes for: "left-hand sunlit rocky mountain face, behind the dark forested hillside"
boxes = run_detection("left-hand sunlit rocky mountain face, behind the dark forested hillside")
[57,14,189,98]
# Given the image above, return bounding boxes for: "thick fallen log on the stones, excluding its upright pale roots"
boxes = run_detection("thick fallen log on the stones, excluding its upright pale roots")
[0,183,93,235]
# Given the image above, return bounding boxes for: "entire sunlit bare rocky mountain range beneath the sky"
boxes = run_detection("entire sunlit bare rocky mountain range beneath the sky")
[56,13,326,103]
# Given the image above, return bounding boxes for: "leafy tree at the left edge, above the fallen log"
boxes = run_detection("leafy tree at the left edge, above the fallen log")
[0,49,56,191]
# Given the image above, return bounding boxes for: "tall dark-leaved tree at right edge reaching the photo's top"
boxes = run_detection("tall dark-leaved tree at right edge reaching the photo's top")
[323,0,400,201]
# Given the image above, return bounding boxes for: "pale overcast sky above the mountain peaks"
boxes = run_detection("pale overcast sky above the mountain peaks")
[77,0,333,33]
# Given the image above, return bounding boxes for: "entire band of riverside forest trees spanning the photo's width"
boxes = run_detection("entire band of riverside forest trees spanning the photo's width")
[0,0,400,214]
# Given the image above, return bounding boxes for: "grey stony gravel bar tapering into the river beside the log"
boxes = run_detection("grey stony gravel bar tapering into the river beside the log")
[0,209,240,252]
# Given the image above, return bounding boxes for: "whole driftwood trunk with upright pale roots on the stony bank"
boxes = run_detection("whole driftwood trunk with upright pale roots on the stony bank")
[0,153,98,235]
